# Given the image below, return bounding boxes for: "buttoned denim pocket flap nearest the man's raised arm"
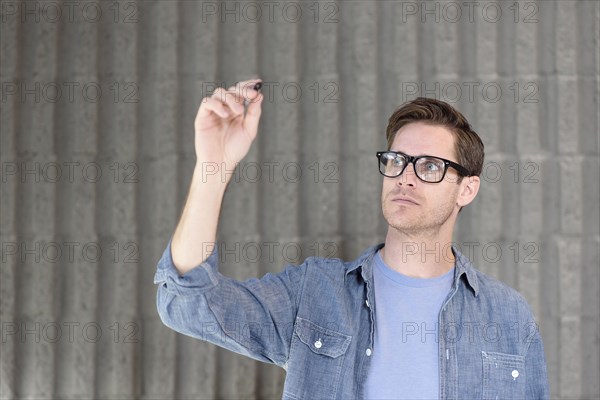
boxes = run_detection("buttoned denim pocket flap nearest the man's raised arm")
[294,317,352,358]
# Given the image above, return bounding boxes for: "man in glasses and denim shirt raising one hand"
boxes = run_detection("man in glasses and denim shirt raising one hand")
[155,80,549,399]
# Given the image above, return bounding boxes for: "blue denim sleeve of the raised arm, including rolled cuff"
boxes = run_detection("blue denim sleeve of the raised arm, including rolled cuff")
[154,241,307,366]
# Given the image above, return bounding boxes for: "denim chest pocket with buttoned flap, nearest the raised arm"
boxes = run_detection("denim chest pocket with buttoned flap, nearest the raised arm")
[283,317,352,399]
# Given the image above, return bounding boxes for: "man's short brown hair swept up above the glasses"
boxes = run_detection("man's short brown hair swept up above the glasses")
[386,97,484,176]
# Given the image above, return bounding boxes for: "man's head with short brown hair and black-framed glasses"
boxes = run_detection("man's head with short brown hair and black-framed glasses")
[380,98,484,234]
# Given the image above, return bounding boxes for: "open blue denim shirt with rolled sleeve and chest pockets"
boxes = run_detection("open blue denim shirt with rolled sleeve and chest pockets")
[154,242,549,399]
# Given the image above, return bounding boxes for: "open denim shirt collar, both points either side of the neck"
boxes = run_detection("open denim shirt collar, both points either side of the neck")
[346,243,479,296]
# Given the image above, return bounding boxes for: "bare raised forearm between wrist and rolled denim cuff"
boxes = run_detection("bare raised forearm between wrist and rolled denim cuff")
[171,163,228,275]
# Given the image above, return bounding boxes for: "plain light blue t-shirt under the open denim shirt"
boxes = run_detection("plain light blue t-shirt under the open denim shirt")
[365,252,454,400]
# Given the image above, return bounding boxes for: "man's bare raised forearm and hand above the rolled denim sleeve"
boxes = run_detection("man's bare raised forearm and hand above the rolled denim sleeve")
[171,79,263,275]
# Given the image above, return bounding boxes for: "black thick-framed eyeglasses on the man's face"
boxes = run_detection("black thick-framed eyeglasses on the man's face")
[377,151,469,183]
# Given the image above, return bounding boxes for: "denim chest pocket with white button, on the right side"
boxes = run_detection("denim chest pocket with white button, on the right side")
[481,351,526,400]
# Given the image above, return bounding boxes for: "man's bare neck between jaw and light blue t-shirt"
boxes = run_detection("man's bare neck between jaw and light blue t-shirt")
[381,227,455,278]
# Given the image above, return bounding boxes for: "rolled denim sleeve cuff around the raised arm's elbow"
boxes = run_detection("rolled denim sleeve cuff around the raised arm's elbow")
[154,240,218,296]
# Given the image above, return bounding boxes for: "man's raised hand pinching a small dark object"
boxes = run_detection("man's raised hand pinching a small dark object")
[194,79,263,170]
